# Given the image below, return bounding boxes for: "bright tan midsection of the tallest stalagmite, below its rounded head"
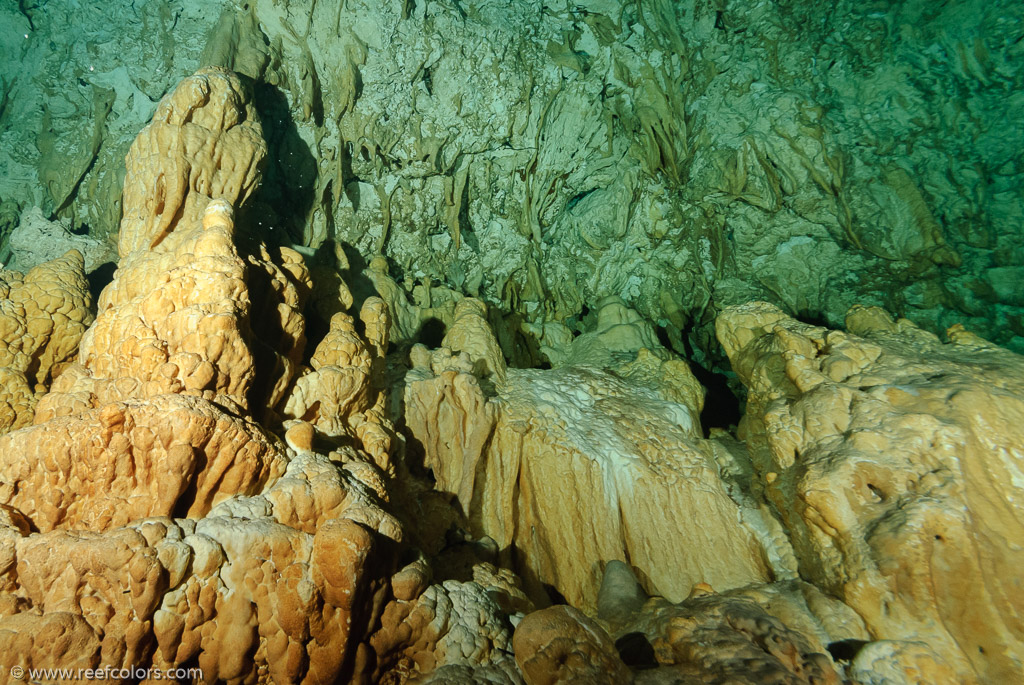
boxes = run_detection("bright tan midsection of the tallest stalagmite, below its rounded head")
[40,201,305,420]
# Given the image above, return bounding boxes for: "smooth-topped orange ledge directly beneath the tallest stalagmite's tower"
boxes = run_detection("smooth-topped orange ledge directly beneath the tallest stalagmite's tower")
[0,395,287,531]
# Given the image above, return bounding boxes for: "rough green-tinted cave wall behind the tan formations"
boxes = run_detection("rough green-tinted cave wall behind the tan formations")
[0,0,1024,358]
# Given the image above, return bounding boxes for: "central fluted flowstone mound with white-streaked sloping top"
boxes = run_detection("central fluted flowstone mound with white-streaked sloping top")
[406,302,770,609]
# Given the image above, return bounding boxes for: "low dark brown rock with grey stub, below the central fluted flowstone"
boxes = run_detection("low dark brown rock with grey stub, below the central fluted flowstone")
[598,561,870,684]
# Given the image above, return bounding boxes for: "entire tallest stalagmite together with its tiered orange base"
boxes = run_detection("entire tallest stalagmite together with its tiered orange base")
[0,70,402,682]
